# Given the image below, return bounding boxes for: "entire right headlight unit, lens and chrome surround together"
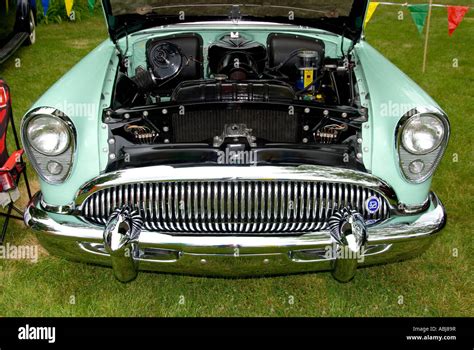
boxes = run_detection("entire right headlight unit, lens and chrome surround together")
[397,108,449,183]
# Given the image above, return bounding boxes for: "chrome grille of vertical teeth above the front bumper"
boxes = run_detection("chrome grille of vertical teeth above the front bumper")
[82,180,389,234]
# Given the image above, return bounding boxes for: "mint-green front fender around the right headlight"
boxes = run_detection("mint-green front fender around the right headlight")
[355,41,441,206]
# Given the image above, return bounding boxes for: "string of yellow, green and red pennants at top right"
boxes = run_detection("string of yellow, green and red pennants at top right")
[364,1,474,36]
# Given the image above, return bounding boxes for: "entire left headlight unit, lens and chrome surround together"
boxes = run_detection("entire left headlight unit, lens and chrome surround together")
[21,107,76,184]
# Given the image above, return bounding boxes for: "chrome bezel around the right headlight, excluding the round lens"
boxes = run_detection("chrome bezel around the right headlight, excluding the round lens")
[396,107,450,184]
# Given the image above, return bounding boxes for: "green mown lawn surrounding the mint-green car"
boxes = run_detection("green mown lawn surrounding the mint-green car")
[0,4,474,316]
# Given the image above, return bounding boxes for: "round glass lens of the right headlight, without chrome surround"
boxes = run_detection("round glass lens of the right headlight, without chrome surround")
[402,114,444,154]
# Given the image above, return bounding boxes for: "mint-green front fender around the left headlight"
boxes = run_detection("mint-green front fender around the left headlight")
[25,40,117,205]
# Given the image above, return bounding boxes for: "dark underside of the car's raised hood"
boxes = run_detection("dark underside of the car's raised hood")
[102,0,368,42]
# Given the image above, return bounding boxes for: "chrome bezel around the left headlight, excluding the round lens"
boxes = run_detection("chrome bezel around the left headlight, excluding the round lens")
[21,107,76,185]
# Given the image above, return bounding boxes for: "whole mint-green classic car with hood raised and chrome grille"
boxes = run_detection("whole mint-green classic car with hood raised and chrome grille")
[22,0,450,282]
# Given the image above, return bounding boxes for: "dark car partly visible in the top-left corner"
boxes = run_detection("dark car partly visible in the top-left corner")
[0,0,36,64]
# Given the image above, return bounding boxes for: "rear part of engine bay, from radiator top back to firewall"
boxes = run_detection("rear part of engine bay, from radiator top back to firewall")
[115,32,354,106]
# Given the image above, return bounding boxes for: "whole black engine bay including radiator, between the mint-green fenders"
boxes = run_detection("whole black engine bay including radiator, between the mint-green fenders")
[104,32,366,170]
